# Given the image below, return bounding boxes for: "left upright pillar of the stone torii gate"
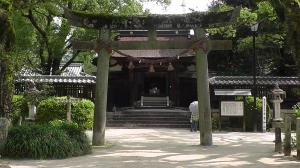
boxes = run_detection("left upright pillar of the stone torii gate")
[93,28,111,146]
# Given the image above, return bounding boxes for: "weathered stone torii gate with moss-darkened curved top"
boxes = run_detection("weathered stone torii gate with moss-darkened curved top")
[65,9,240,146]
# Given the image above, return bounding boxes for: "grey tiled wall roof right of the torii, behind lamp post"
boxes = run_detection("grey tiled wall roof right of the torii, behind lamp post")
[209,76,300,86]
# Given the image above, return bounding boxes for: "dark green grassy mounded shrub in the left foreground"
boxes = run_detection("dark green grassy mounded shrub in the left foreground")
[2,121,91,159]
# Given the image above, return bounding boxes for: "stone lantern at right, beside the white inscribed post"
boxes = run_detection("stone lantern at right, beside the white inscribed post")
[272,84,286,122]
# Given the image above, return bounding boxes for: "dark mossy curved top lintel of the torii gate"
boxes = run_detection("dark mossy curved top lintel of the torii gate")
[64,8,240,30]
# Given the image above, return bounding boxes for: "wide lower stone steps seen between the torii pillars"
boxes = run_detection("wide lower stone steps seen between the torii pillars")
[107,108,190,128]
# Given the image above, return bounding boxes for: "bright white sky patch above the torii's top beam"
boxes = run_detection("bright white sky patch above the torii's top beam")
[144,0,213,14]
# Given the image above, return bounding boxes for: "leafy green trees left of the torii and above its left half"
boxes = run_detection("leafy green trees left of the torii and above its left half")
[9,0,150,74]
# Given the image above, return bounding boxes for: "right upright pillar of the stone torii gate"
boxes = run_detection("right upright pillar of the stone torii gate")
[195,28,212,146]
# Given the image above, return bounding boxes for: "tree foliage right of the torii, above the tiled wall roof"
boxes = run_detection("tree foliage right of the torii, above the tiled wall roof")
[208,0,300,76]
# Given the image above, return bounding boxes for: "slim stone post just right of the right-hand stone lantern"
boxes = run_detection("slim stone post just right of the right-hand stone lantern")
[283,115,292,156]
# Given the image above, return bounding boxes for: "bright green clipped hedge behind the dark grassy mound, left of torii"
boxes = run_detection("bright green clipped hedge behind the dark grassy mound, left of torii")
[36,97,94,129]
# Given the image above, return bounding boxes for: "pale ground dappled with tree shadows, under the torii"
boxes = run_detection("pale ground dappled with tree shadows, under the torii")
[0,129,300,168]
